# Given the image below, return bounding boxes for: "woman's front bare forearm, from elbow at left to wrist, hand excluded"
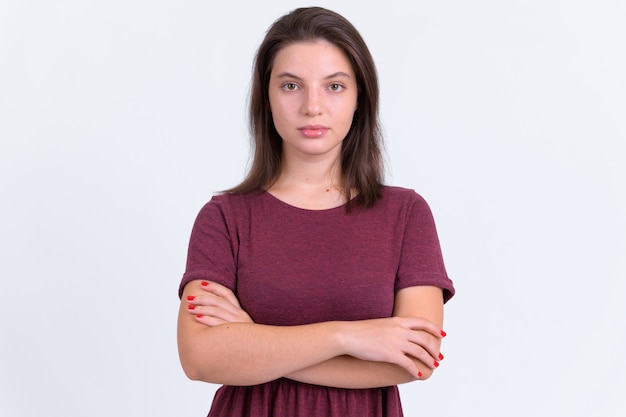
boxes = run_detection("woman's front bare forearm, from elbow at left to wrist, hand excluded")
[178,306,341,385]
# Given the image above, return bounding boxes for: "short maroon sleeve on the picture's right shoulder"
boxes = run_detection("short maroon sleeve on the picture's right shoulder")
[395,193,454,302]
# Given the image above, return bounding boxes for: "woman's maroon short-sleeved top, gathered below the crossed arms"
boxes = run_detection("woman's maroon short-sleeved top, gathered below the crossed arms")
[179,187,454,417]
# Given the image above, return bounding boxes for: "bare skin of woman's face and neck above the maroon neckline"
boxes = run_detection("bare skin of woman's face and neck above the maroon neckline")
[268,41,358,210]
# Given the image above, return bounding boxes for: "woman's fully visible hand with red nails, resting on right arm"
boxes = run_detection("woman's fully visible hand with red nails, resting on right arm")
[340,317,445,378]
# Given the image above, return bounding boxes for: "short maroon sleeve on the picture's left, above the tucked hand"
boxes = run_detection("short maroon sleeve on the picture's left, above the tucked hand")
[178,196,237,297]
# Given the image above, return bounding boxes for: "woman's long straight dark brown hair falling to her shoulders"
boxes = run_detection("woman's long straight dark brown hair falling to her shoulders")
[227,7,383,209]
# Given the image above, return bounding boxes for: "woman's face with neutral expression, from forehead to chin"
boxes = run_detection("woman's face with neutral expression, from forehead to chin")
[269,40,358,159]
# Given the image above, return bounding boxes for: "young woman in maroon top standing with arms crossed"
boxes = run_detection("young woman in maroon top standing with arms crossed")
[178,8,454,417]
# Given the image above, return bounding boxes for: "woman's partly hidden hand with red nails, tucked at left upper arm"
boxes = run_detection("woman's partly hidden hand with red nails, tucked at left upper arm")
[186,281,254,326]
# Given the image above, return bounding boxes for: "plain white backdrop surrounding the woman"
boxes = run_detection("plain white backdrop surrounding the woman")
[0,0,626,417]
